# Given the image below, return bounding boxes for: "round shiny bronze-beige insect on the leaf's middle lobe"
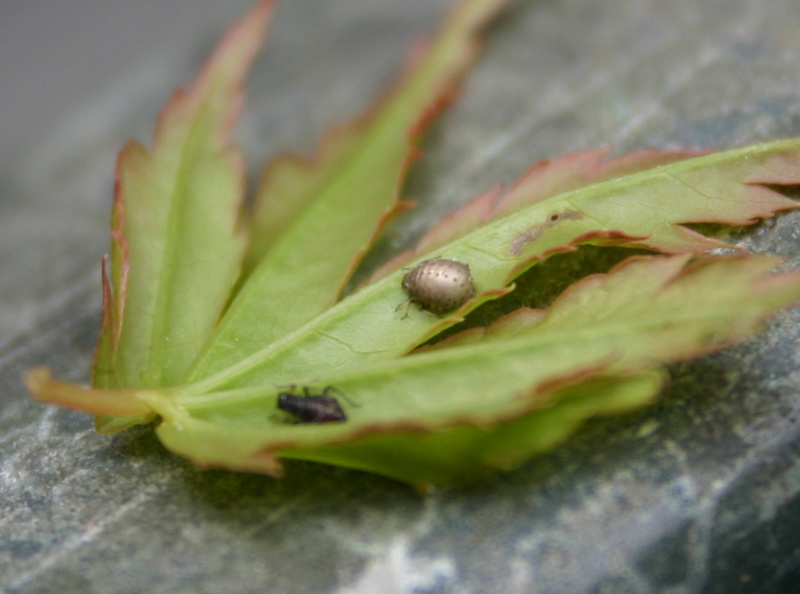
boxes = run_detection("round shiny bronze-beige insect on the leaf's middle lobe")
[403,259,475,315]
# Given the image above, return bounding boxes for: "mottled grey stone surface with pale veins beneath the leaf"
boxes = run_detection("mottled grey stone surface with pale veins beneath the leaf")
[0,0,800,594]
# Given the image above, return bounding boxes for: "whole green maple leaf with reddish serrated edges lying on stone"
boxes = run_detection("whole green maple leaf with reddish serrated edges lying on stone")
[21,0,800,486]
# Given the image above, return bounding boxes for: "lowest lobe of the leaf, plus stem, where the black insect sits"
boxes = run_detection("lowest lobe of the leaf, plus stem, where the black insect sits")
[23,255,800,486]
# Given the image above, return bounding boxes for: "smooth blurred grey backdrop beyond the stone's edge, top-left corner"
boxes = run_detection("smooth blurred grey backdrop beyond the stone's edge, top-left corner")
[0,0,249,160]
